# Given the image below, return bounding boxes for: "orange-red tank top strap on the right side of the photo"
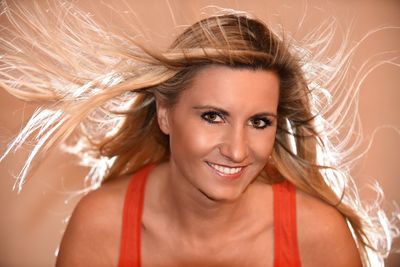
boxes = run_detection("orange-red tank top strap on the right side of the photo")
[272,180,301,267]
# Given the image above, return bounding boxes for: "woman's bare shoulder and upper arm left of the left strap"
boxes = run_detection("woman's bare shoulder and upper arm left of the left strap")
[57,177,129,266]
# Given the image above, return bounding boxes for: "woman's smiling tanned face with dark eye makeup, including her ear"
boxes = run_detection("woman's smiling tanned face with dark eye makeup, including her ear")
[158,66,279,201]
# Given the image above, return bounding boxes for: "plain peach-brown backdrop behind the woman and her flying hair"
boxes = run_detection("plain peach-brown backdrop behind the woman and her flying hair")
[0,0,400,267]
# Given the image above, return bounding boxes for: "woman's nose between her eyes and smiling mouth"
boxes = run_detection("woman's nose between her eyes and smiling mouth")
[219,127,249,163]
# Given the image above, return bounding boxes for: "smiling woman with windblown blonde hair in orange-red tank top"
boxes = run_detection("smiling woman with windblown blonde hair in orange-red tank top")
[3,2,389,266]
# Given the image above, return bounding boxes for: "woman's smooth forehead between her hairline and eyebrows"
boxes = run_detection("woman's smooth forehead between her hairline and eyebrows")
[179,66,279,112]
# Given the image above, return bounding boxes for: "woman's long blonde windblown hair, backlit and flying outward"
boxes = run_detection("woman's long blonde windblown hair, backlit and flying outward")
[0,1,397,266]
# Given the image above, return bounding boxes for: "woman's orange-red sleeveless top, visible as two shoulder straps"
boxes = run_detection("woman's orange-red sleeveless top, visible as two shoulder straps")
[118,165,301,267]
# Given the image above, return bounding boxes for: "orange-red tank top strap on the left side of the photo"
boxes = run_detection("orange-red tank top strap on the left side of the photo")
[118,165,154,267]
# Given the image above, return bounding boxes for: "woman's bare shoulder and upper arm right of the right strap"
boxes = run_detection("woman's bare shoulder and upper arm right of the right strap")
[297,190,361,267]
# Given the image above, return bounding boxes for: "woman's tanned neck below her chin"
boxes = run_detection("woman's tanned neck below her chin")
[160,164,253,240]
